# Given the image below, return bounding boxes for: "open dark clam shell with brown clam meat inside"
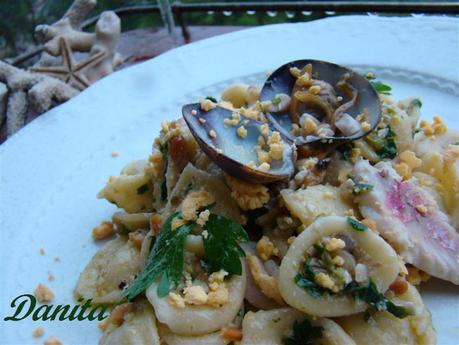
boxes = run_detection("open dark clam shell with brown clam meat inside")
[260,60,381,146]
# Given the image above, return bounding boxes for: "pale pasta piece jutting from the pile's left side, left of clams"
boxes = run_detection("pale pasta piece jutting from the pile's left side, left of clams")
[97,160,153,213]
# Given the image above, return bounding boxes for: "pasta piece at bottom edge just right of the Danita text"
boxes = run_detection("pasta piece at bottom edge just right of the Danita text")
[99,303,161,345]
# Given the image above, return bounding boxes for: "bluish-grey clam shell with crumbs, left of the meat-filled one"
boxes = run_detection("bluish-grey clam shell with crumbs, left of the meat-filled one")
[182,103,296,183]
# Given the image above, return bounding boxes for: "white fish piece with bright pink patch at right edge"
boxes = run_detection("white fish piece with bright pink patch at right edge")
[353,160,459,285]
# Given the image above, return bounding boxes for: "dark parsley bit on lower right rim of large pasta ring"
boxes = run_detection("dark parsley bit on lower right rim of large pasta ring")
[344,278,413,319]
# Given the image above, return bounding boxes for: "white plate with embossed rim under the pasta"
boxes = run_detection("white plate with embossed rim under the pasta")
[0,16,459,344]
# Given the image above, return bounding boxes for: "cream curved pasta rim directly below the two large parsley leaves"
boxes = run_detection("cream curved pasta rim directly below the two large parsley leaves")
[146,264,246,335]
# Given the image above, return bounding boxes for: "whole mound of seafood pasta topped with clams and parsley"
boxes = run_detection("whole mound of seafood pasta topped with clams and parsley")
[75,71,450,345]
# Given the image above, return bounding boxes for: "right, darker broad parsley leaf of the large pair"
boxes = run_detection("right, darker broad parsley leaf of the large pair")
[203,214,249,275]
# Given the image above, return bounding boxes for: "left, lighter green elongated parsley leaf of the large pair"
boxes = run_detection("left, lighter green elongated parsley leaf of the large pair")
[123,212,194,301]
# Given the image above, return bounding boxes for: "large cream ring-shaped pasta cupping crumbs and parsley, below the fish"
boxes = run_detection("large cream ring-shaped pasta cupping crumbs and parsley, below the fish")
[279,216,399,317]
